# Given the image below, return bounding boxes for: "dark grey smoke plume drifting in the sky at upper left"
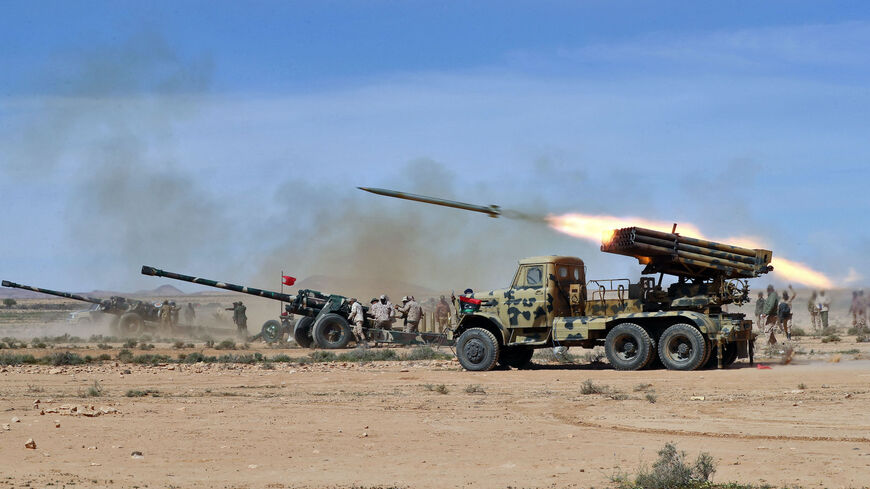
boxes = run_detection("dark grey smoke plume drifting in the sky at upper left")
[2,34,230,283]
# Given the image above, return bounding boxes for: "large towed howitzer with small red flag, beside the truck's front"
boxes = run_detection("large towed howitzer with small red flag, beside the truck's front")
[142,266,449,349]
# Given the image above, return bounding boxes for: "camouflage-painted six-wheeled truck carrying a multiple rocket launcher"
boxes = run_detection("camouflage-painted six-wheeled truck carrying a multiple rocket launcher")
[452,227,772,371]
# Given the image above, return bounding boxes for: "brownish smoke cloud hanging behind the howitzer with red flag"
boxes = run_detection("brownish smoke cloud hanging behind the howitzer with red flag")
[257,159,553,299]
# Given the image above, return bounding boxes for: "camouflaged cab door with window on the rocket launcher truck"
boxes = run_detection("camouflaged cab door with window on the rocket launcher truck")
[504,264,548,328]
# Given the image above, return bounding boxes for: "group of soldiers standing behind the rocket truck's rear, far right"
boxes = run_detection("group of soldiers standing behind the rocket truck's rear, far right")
[755,285,844,343]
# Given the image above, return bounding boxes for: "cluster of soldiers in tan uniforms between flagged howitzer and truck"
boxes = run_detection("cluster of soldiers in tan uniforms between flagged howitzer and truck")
[348,294,450,346]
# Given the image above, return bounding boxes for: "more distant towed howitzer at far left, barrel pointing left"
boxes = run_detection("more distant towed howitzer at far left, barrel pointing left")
[2,280,158,336]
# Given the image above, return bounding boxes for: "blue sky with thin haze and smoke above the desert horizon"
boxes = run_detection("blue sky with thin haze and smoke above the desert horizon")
[0,1,870,290]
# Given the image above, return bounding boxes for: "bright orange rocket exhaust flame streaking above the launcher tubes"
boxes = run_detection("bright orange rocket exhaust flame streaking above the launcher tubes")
[547,213,834,289]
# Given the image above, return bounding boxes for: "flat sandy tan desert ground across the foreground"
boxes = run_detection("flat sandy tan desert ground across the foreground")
[0,292,870,488]
